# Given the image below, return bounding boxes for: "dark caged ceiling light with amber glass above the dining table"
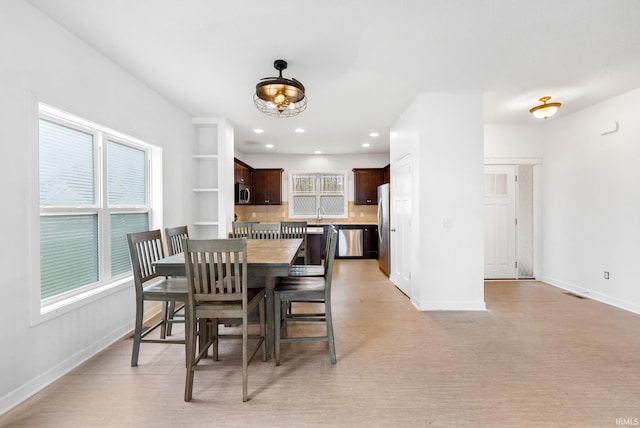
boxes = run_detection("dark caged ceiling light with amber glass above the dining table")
[253,59,307,117]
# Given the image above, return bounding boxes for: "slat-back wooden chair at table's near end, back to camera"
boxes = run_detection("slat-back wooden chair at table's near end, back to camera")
[184,239,266,401]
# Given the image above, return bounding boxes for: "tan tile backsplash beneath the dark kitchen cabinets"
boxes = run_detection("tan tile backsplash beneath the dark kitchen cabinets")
[234,201,378,224]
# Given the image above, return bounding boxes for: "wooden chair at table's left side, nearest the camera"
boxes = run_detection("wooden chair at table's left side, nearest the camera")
[127,229,188,367]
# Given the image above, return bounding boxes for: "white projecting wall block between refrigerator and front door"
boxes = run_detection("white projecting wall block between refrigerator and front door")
[391,94,485,310]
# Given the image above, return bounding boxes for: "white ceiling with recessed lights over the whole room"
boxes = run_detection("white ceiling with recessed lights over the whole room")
[29,0,640,154]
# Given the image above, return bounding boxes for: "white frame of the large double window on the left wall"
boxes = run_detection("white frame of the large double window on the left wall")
[29,103,162,325]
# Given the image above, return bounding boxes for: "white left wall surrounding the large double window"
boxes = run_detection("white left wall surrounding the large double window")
[0,0,194,413]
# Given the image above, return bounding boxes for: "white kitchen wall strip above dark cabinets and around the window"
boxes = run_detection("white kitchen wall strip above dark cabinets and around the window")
[236,153,389,201]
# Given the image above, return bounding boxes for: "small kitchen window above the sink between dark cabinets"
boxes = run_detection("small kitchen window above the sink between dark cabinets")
[289,173,348,218]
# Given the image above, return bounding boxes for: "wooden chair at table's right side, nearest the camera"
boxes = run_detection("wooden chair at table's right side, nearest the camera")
[274,222,338,366]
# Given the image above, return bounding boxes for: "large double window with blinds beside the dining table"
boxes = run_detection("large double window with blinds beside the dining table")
[38,105,153,312]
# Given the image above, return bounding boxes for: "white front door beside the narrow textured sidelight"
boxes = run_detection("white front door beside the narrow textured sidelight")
[484,165,517,279]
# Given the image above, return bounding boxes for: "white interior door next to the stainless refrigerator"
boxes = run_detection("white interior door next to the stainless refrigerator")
[389,156,412,297]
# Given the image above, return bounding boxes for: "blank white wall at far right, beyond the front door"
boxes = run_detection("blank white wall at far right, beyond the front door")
[542,89,640,313]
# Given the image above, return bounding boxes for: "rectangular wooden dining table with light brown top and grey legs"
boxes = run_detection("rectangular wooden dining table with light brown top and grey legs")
[153,238,303,358]
